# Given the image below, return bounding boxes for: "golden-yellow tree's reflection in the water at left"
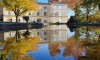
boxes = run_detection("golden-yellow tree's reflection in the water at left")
[0,34,39,60]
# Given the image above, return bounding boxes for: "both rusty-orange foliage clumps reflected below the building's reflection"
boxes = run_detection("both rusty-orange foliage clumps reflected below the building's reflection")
[48,37,85,59]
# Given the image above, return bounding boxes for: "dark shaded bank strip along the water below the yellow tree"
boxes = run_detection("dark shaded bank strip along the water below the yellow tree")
[0,22,44,31]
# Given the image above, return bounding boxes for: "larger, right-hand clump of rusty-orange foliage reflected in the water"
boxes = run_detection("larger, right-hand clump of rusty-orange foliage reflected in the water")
[63,37,85,59]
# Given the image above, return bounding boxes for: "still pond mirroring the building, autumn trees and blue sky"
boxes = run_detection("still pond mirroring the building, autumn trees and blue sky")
[0,25,100,60]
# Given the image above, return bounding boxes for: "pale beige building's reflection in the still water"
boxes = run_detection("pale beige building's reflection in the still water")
[0,25,68,42]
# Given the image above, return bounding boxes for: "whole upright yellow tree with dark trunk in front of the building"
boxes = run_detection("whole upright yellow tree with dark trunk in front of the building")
[2,0,37,22]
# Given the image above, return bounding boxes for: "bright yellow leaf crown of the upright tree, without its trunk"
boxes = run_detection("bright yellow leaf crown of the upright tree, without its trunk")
[3,0,38,11]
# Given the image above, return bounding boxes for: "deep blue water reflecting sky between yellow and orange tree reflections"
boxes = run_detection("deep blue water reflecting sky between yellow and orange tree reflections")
[29,44,74,60]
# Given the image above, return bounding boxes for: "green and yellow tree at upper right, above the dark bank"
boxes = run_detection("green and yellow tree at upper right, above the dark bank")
[74,0,100,22]
